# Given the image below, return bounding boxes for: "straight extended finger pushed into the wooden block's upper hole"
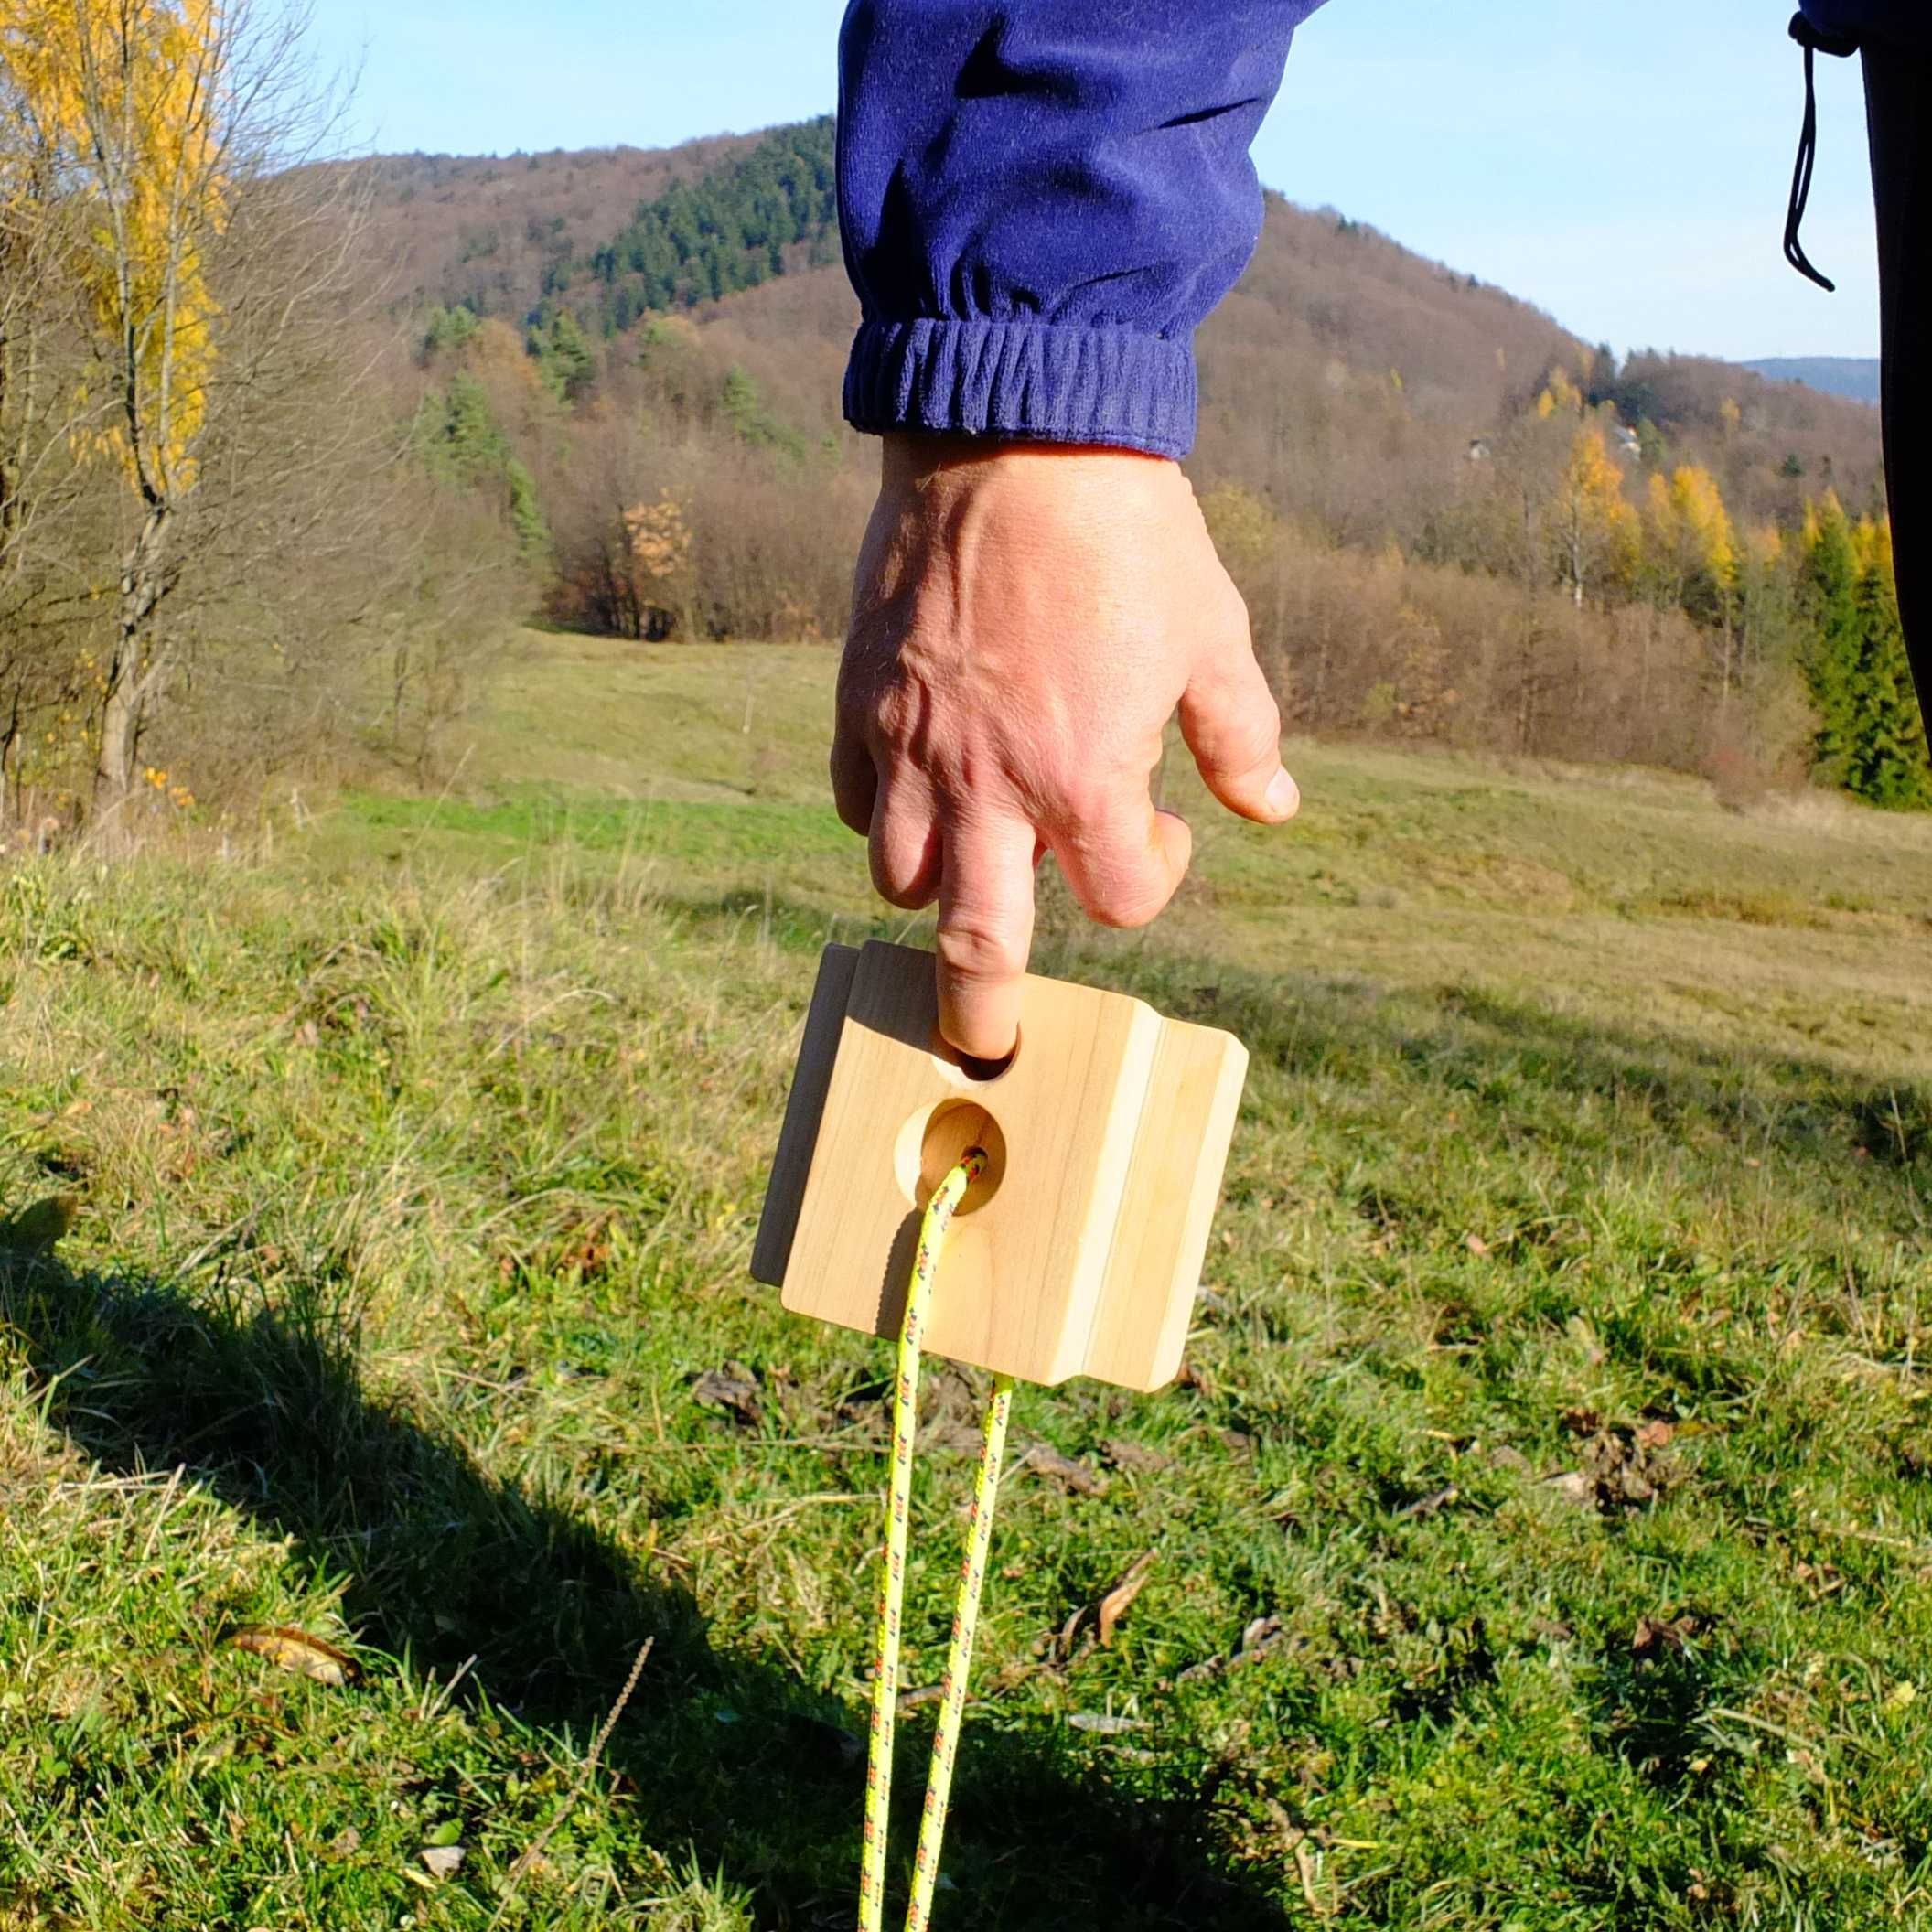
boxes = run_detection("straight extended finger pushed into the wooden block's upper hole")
[935,817,1037,1060]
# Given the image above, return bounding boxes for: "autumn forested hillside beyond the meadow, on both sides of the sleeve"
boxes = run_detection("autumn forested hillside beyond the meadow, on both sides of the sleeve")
[369,120,1908,804]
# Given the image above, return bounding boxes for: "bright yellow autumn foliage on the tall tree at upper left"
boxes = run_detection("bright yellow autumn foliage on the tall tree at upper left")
[0,0,228,497]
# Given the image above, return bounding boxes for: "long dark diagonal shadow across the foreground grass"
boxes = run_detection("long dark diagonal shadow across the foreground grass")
[0,1254,1287,1932]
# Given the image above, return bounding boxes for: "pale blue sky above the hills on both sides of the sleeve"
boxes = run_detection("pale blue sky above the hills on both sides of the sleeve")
[315,0,1878,358]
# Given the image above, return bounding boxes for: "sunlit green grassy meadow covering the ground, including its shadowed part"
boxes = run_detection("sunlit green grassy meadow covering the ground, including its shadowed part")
[0,639,1932,1932]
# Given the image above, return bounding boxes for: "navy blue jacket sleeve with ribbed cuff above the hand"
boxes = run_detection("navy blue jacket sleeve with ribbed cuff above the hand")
[839,0,1319,456]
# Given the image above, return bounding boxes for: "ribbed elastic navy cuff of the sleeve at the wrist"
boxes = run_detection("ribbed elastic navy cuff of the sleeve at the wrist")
[844,317,1194,456]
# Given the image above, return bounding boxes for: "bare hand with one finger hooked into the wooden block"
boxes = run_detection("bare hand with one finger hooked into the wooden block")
[831,436,1300,1058]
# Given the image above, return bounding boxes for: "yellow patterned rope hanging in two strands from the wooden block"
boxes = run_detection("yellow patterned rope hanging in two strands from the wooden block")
[858,1148,1013,1932]
